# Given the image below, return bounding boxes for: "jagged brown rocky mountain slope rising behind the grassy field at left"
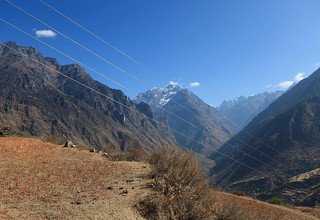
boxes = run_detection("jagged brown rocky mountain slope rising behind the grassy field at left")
[0,42,175,150]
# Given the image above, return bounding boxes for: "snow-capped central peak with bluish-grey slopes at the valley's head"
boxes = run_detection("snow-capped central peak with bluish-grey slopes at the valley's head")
[136,84,237,155]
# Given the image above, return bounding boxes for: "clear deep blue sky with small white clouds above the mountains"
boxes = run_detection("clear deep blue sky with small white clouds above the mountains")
[0,0,320,106]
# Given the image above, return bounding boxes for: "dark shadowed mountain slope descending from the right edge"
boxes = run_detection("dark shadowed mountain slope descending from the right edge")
[211,69,320,205]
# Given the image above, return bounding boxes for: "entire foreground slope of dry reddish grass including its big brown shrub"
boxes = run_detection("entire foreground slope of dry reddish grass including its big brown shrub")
[0,137,319,220]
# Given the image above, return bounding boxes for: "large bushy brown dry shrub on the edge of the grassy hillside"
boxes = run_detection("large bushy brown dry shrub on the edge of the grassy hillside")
[140,148,215,219]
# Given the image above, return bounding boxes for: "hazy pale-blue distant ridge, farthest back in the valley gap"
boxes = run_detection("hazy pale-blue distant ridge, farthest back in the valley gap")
[217,91,284,127]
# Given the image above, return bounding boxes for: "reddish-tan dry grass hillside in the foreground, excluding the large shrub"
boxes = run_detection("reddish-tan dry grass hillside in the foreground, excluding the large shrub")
[0,137,319,220]
